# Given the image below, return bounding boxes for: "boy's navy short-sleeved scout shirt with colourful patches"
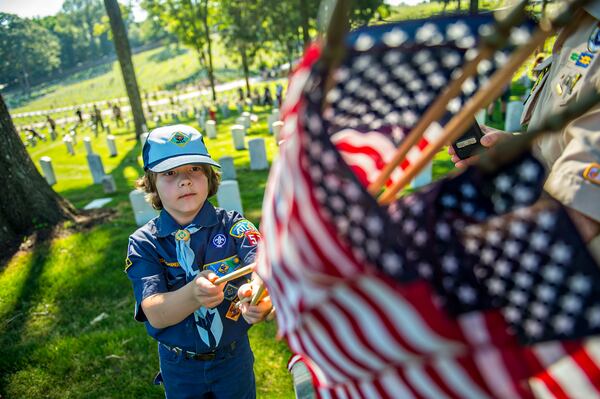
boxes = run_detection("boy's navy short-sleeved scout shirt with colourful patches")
[125,201,260,353]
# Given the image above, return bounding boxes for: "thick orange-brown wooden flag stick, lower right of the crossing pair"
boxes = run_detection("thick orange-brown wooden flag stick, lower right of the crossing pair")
[378,26,554,205]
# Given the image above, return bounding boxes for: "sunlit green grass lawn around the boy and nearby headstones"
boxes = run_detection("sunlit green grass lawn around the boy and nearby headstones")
[0,107,293,398]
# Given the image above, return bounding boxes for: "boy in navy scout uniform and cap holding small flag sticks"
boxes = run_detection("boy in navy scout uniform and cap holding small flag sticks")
[125,125,271,399]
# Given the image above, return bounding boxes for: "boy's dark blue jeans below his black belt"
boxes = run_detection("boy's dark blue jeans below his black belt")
[158,336,256,399]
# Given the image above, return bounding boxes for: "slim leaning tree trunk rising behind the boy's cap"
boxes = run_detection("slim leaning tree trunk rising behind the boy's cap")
[104,0,146,140]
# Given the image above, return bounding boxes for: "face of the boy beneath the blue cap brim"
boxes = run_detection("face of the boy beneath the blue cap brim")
[156,165,208,226]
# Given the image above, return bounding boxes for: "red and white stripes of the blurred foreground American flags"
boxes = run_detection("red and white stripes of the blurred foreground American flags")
[257,45,600,399]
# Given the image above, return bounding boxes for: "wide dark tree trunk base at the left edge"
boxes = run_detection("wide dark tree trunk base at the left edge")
[0,94,76,253]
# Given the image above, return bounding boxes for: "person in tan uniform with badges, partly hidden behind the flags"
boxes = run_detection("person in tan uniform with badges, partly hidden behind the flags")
[448,0,600,263]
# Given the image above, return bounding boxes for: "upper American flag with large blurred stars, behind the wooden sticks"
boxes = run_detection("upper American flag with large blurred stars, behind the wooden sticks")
[323,15,532,189]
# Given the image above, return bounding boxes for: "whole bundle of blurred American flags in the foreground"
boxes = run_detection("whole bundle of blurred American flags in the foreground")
[257,12,600,398]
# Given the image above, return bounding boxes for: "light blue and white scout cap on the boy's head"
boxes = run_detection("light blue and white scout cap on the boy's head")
[142,125,221,172]
